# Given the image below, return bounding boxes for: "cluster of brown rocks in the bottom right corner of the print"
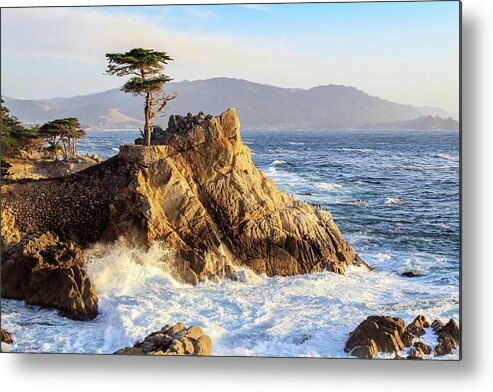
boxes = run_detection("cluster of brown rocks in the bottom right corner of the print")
[344,315,460,359]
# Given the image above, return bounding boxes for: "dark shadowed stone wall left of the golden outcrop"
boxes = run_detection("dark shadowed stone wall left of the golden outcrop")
[2,158,138,245]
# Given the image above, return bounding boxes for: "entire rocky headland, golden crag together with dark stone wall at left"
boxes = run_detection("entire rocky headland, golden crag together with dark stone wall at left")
[2,109,369,283]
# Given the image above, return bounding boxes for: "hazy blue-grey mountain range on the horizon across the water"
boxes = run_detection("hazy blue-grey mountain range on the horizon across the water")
[4,78,448,129]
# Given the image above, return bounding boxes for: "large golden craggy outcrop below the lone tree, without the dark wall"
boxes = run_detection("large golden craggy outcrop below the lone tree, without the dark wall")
[105,109,367,283]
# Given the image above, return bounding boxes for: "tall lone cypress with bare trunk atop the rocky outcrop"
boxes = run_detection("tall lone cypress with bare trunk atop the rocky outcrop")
[106,48,177,146]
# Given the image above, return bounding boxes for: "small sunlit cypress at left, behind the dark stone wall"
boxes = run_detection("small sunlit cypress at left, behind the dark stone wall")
[40,117,86,161]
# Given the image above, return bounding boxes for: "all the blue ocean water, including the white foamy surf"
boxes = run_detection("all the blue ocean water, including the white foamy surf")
[2,130,459,359]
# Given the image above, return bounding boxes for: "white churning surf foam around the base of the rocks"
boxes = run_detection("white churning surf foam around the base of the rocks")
[2,245,458,357]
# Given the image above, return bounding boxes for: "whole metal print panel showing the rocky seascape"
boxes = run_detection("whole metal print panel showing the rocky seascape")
[1,1,461,360]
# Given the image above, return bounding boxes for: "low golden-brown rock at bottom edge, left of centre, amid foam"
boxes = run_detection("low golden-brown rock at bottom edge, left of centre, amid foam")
[115,323,212,355]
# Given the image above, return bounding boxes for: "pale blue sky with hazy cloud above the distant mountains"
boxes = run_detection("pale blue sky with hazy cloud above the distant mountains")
[1,1,459,113]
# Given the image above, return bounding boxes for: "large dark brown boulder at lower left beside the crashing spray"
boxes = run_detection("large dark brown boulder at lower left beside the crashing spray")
[1,232,98,320]
